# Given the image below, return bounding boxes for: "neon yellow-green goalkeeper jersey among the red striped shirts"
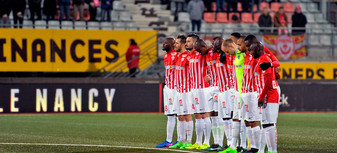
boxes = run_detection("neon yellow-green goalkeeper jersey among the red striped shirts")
[234,50,246,95]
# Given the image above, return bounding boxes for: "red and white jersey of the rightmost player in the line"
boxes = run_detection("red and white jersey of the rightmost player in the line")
[254,54,279,103]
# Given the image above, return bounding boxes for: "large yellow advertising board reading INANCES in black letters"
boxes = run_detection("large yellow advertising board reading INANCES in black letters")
[0,29,157,72]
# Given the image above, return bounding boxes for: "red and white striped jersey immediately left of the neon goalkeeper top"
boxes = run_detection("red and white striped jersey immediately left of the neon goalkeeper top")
[216,54,231,92]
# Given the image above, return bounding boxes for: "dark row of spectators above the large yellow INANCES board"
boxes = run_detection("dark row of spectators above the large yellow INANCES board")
[0,0,113,28]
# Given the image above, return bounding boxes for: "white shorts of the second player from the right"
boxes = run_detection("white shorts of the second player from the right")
[241,92,262,122]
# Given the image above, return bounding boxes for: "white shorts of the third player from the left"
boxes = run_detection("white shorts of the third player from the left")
[191,88,211,113]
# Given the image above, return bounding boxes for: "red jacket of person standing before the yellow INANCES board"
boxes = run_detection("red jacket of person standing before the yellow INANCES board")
[125,45,140,68]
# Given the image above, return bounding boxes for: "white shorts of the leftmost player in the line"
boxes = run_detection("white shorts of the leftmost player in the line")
[163,86,177,115]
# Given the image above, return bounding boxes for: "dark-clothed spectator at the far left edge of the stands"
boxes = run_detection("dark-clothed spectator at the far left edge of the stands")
[0,0,11,28]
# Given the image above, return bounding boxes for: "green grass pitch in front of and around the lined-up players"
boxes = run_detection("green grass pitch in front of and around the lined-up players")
[0,113,337,153]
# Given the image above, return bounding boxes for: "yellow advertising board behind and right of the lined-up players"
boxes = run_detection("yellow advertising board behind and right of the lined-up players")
[280,62,337,80]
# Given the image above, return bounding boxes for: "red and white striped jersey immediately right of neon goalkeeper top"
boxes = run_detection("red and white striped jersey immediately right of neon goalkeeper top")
[242,52,256,93]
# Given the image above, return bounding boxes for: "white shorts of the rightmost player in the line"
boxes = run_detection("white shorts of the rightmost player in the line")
[262,103,279,124]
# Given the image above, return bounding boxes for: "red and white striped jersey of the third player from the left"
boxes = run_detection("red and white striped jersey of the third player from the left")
[189,50,209,89]
